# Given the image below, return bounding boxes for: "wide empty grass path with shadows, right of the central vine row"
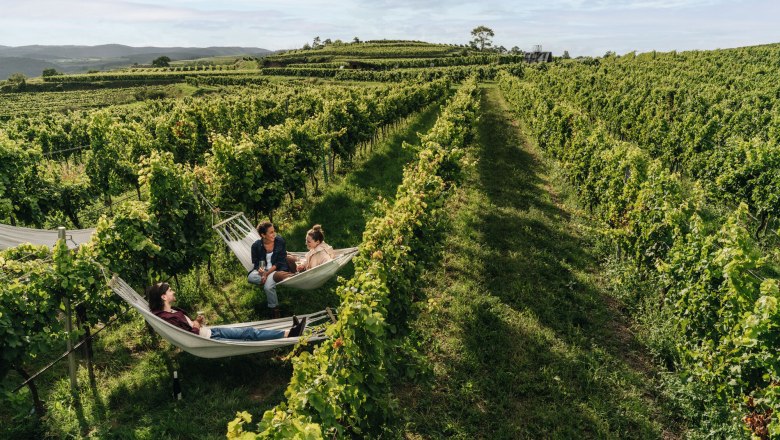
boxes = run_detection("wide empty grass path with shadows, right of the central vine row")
[397,87,673,439]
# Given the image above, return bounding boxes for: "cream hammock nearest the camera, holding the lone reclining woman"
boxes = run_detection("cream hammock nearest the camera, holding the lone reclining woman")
[108,275,332,358]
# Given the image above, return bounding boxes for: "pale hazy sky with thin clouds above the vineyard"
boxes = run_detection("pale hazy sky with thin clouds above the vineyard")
[0,0,780,56]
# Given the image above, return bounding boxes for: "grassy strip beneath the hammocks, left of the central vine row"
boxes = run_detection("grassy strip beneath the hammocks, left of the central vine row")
[0,100,439,439]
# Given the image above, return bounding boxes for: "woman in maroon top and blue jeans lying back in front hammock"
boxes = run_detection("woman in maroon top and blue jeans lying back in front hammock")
[146,283,306,341]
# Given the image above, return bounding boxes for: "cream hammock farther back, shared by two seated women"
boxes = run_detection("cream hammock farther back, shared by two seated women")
[213,212,358,290]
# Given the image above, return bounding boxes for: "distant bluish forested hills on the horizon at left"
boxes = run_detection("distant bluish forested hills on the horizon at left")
[0,44,271,80]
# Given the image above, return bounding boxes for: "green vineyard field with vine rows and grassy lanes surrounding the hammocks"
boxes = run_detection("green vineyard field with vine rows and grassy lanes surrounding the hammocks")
[0,41,780,439]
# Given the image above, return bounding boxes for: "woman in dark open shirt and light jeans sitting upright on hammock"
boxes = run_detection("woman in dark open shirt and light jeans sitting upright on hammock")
[247,222,296,318]
